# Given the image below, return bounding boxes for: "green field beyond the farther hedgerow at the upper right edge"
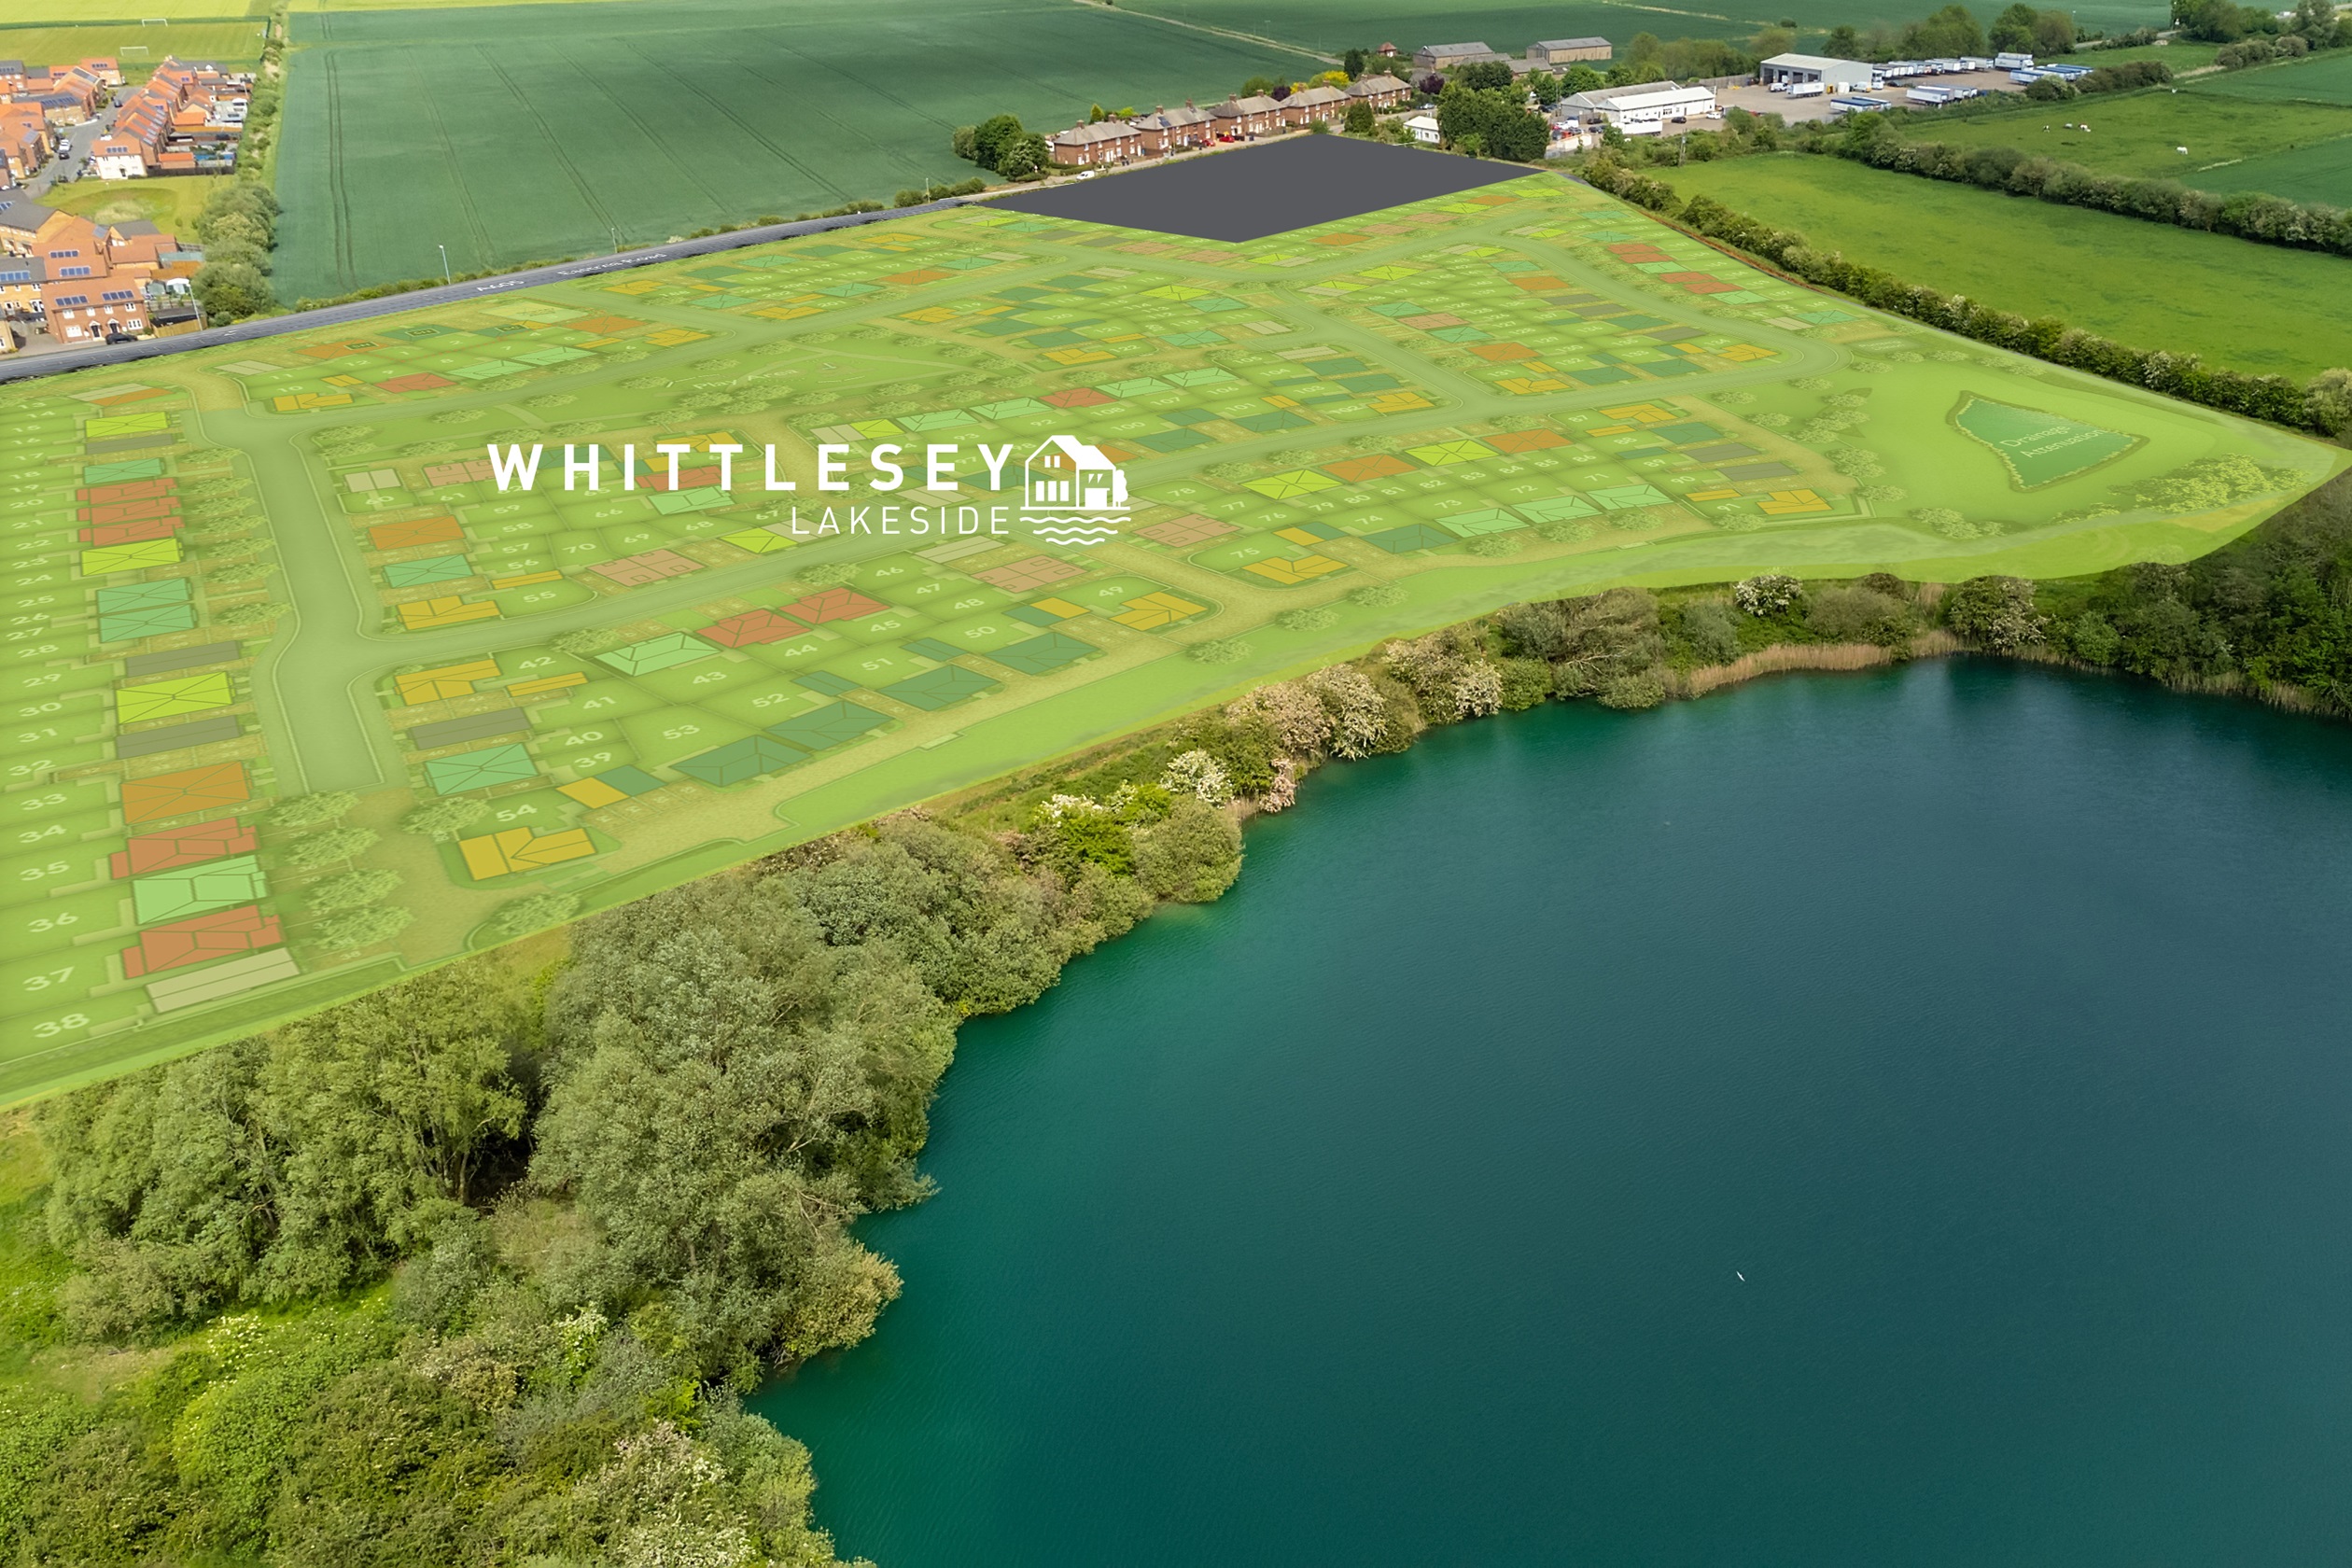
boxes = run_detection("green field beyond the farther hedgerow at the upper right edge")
[1903,85,2352,204]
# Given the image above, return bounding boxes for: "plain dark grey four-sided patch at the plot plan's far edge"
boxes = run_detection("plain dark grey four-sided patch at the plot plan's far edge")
[997,136,1529,242]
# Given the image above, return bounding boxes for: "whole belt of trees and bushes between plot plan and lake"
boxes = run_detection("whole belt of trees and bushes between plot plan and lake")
[0,475,2352,1568]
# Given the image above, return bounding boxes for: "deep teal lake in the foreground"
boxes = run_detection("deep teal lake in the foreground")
[760,661,2352,1568]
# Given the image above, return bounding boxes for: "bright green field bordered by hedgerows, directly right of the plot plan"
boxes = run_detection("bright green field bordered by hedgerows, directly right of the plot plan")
[1656,153,2352,381]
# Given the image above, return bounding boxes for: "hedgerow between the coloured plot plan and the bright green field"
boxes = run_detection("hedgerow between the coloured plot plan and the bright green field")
[1585,158,2352,435]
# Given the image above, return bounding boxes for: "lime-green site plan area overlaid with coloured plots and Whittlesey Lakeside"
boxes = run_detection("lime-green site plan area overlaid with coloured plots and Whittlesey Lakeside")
[0,153,2345,1100]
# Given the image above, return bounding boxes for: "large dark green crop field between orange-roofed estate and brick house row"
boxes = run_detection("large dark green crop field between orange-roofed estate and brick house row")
[275,0,1315,299]
